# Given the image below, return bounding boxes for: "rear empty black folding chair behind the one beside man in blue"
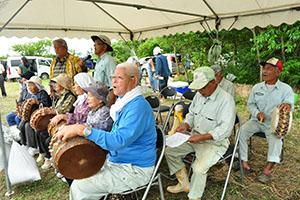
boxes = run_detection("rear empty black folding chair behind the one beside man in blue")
[153,86,177,124]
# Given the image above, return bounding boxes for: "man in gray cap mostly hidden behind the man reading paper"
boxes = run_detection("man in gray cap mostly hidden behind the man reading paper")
[210,65,234,98]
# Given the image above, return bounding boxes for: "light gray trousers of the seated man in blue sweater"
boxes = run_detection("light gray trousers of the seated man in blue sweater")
[70,160,154,200]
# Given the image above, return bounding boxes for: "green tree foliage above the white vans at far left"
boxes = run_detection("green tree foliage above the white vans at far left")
[12,40,52,56]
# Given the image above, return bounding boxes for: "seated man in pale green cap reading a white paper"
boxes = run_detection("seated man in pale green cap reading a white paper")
[166,67,236,200]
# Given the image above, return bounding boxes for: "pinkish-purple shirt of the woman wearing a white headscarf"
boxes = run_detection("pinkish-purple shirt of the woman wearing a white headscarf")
[66,98,91,124]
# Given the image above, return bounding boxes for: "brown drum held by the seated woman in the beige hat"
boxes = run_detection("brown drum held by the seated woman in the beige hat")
[30,107,56,131]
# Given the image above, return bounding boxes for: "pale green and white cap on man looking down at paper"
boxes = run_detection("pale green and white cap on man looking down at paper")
[189,67,216,90]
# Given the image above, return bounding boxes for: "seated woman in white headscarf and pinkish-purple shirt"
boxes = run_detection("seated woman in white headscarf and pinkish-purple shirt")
[51,72,94,125]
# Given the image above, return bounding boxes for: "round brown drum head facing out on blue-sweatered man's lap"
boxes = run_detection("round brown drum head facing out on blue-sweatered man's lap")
[56,139,106,179]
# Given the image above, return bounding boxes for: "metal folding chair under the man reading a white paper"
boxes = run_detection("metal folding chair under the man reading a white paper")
[184,114,244,200]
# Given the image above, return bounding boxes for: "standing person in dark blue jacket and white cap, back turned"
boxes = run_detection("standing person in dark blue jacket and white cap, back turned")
[153,47,171,101]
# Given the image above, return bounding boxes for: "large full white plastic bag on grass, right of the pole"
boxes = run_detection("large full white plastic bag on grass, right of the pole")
[8,142,41,185]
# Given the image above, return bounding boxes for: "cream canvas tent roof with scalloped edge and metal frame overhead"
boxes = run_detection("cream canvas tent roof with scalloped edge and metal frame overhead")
[0,0,300,39]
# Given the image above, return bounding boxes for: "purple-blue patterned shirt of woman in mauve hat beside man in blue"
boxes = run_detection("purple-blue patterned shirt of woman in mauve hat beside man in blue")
[85,106,113,131]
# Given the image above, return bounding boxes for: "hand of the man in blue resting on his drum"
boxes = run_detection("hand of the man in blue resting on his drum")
[56,124,88,142]
